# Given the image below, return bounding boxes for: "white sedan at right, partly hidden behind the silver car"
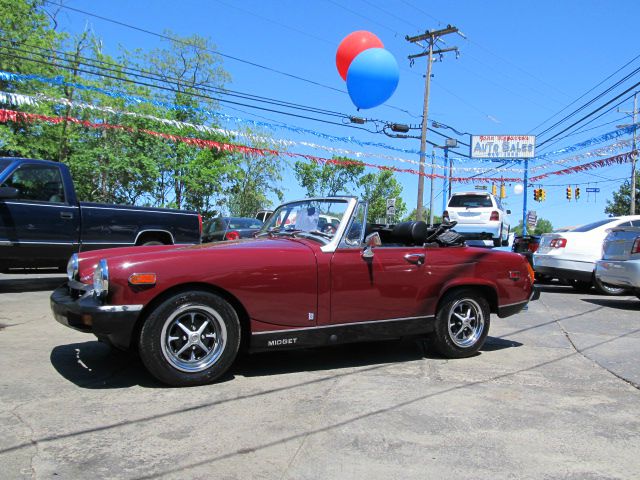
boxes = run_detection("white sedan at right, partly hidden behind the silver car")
[533,215,640,295]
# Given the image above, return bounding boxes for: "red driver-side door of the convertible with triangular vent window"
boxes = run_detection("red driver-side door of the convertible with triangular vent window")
[330,202,429,324]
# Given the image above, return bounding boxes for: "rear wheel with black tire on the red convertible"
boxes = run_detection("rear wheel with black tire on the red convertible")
[428,289,491,358]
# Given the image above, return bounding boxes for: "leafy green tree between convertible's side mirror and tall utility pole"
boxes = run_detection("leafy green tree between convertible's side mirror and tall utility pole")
[358,170,407,222]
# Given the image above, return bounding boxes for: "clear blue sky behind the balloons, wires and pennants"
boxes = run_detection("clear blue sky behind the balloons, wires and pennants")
[48,0,640,227]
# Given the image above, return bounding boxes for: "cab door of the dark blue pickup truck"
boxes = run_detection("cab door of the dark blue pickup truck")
[0,163,79,268]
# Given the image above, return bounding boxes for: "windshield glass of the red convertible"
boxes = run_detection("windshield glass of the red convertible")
[260,199,348,241]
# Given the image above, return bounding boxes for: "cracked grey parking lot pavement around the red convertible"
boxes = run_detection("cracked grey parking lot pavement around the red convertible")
[0,275,640,480]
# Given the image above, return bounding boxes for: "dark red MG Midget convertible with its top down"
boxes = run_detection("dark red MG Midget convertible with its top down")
[51,197,535,386]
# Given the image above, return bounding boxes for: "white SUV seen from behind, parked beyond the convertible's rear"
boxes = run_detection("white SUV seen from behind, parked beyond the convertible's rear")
[443,191,511,247]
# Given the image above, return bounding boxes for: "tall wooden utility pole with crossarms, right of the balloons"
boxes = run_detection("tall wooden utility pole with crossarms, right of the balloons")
[405,25,462,225]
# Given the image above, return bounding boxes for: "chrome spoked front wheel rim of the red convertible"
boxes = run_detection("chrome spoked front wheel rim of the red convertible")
[161,303,227,373]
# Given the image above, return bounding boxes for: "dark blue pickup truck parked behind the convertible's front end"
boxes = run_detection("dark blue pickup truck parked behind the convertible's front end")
[0,158,202,273]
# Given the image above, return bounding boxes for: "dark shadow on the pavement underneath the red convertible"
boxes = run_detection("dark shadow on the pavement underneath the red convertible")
[50,337,522,389]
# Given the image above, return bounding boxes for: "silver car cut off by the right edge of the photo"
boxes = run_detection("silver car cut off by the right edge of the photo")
[596,227,640,298]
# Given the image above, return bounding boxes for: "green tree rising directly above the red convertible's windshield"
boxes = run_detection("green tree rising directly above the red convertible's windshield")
[293,157,364,197]
